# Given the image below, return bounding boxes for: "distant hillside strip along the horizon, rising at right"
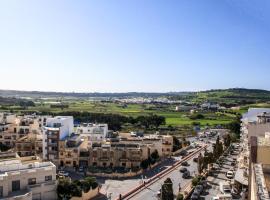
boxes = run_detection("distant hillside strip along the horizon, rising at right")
[0,88,270,106]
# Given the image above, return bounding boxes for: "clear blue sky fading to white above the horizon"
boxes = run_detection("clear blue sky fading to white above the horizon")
[0,0,270,92]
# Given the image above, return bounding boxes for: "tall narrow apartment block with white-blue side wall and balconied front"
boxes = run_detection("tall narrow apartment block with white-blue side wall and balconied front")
[42,116,74,166]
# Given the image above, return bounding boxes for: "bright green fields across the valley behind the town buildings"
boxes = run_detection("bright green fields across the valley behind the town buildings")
[0,100,235,127]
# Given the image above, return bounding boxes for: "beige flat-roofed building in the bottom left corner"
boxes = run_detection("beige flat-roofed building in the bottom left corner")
[0,152,57,200]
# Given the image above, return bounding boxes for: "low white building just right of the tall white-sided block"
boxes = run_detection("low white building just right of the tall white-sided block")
[76,123,108,141]
